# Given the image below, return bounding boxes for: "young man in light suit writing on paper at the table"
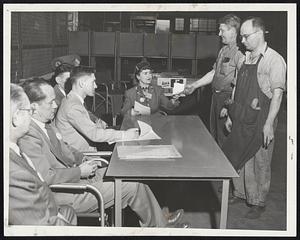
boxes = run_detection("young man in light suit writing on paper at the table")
[55,67,138,151]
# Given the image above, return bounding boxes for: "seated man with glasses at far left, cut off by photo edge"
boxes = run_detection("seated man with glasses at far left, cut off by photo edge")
[8,84,77,225]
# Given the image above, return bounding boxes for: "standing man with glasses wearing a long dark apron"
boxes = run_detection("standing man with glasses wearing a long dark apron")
[222,17,286,219]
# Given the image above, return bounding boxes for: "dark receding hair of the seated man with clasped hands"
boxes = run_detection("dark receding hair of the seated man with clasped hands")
[22,78,51,103]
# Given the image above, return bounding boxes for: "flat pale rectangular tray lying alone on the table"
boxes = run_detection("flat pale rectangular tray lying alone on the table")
[117,145,182,159]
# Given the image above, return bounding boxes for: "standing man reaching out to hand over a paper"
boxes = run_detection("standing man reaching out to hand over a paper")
[185,14,244,146]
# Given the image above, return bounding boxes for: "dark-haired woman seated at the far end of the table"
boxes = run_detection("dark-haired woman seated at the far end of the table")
[121,61,179,116]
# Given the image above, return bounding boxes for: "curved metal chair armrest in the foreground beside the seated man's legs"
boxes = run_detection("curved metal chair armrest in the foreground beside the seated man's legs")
[49,183,104,227]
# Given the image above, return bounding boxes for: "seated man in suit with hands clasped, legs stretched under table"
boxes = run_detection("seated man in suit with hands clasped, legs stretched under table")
[19,79,188,227]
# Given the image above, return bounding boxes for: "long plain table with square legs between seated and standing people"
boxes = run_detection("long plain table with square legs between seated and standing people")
[106,115,238,228]
